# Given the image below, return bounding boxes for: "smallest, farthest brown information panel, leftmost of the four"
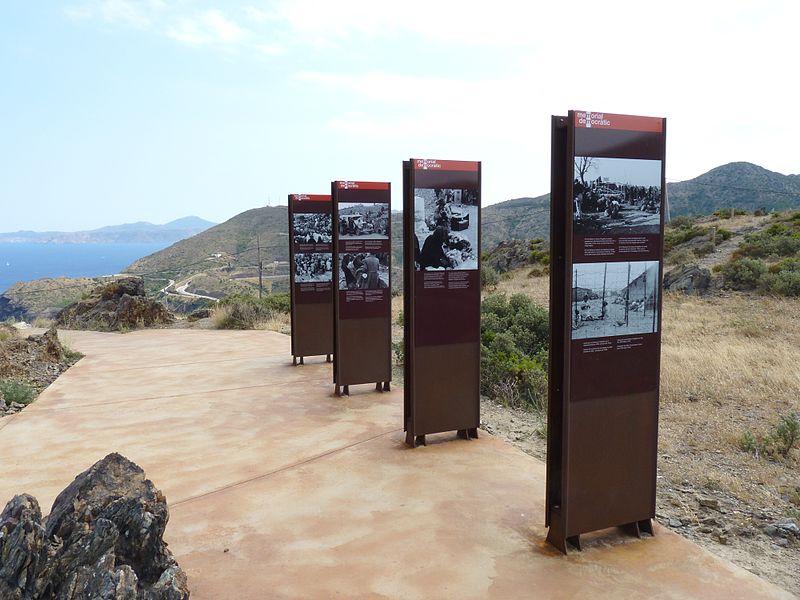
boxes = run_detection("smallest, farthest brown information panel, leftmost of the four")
[289,194,333,364]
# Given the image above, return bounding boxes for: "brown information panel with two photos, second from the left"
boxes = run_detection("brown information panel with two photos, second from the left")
[331,181,392,394]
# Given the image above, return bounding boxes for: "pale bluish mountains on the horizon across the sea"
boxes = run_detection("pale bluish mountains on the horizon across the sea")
[0,217,214,244]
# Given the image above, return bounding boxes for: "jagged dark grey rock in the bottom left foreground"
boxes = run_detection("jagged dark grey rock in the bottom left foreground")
[0,453,189,600]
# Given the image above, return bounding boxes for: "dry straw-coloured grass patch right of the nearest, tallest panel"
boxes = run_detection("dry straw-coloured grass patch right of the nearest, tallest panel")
[660,295,800,505]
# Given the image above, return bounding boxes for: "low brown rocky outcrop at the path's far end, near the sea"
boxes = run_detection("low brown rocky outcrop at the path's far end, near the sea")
[56,277,175,331]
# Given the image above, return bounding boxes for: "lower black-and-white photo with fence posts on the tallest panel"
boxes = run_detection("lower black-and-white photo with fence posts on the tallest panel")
[571,260,659,340]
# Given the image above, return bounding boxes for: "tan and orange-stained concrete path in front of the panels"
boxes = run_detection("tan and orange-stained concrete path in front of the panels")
[0,330,793,600]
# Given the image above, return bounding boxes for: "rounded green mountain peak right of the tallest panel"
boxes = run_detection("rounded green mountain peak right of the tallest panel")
[667,162,800,217]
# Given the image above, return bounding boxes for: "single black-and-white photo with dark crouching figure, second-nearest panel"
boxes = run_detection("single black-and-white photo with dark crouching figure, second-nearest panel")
[414,188,479,271]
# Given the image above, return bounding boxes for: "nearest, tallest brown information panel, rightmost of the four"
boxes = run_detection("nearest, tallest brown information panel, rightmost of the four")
[547,111,666,552]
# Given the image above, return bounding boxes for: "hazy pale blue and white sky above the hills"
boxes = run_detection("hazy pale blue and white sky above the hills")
[0,0,800,231]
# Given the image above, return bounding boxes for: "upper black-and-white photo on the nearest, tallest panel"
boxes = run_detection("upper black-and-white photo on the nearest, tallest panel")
[572,156,661,235]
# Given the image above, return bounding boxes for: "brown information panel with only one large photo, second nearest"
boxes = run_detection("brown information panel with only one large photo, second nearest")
[403,159,481,447]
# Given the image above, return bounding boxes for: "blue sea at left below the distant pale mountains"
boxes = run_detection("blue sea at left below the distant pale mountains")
[0,244,170,293]
